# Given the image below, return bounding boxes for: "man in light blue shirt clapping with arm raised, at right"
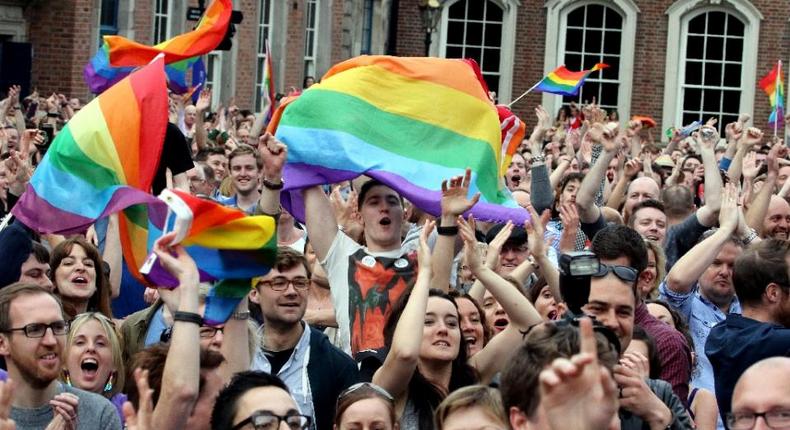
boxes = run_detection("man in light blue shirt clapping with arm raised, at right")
[659,190,743,402]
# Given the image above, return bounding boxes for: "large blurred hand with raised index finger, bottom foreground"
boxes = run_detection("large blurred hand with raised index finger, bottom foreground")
[539,318,618,430]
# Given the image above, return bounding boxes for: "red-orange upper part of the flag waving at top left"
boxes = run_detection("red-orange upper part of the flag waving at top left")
[104,0,233,67]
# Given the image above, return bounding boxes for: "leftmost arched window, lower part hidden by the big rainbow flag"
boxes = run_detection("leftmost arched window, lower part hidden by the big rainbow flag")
[435,0,518,103]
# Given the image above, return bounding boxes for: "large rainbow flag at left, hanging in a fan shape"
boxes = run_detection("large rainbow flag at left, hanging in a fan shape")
[14,58,168,233]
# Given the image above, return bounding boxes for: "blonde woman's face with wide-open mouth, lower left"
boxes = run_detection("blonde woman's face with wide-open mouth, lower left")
[66,319,117,394]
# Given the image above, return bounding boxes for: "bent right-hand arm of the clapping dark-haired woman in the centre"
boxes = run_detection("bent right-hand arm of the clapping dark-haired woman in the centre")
[458,217,542,384]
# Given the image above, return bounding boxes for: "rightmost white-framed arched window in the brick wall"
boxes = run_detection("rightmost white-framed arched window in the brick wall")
[664,0,762,134]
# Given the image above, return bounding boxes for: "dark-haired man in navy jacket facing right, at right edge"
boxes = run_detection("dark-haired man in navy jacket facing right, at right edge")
[705,239,790,424]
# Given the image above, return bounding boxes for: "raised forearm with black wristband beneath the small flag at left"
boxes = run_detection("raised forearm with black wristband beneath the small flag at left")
[153,233,200,429]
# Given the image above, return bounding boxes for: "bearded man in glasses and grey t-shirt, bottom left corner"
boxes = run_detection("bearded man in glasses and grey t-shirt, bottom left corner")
[0,283,121,430]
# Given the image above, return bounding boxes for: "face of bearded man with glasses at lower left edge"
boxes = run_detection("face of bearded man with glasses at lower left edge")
[0,294,66,389]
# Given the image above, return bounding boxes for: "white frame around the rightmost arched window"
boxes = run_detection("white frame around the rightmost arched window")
[662,0,764,140]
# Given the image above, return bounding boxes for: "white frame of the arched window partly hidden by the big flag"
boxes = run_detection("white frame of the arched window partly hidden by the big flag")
[430,0,521,104]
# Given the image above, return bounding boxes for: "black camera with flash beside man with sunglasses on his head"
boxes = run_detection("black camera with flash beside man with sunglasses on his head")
[559,251,601,315]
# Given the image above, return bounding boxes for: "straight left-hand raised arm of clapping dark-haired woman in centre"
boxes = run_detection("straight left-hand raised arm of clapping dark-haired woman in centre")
[373,222,434,398]
